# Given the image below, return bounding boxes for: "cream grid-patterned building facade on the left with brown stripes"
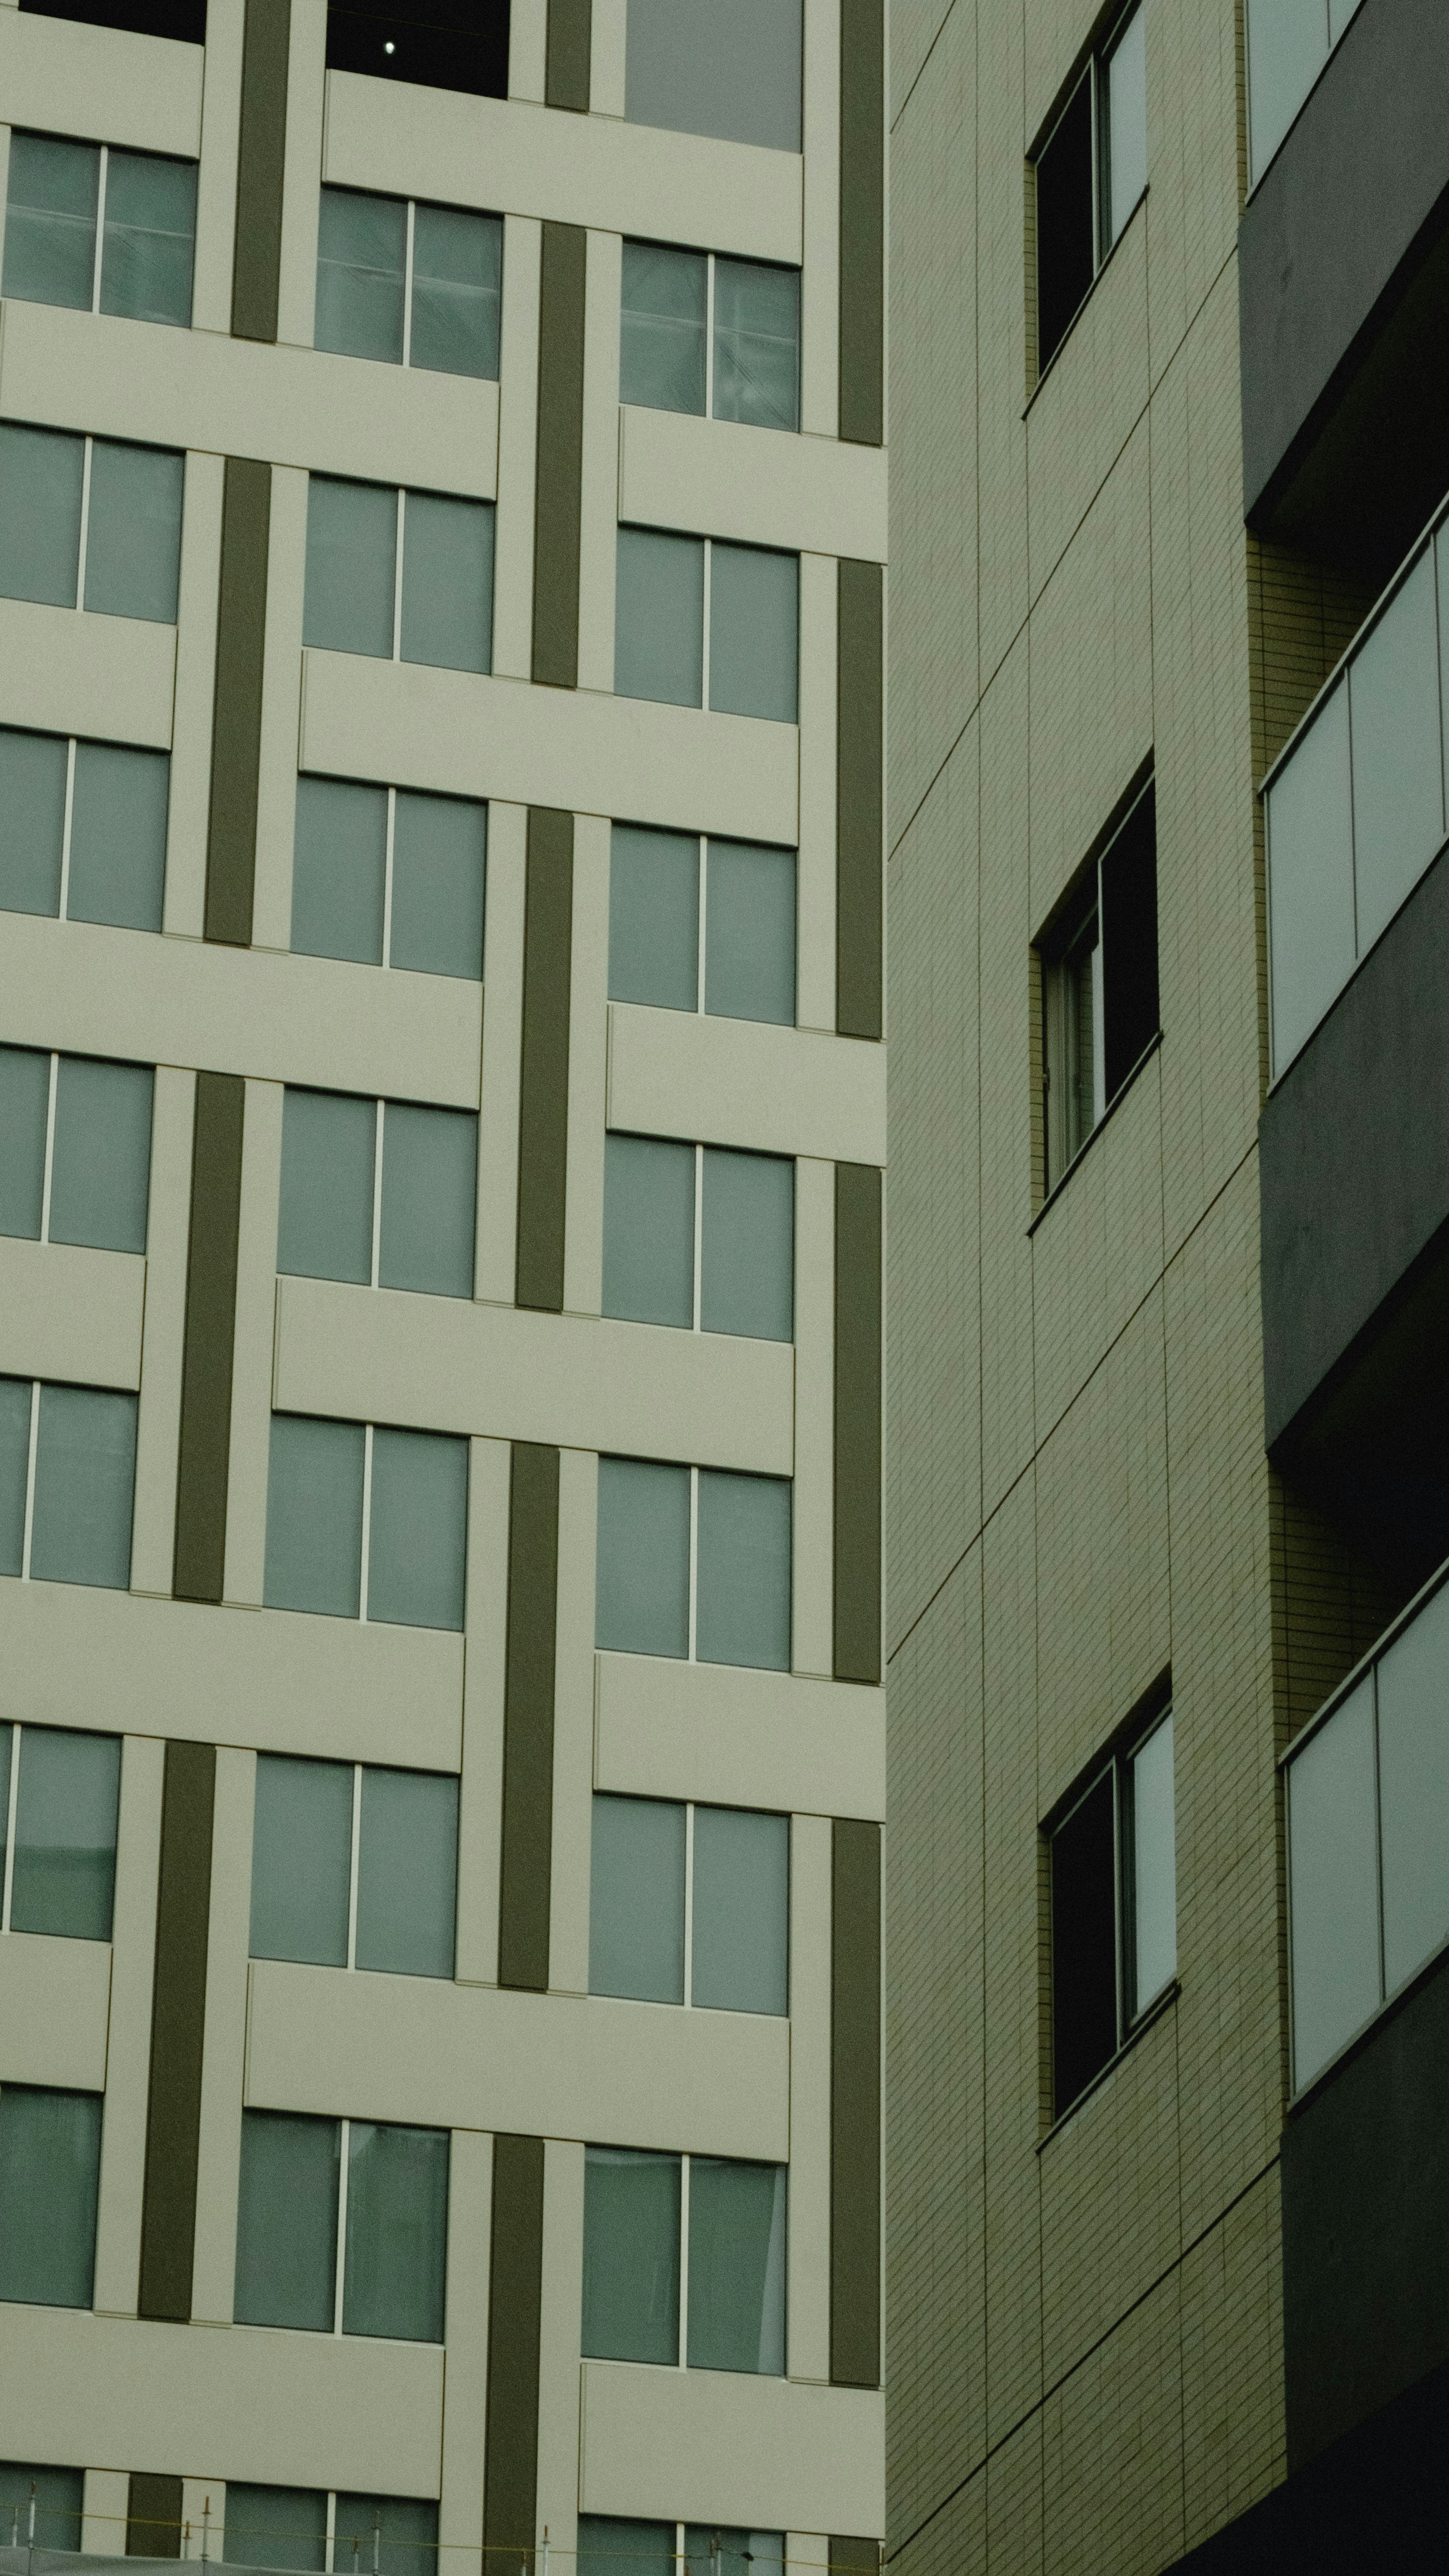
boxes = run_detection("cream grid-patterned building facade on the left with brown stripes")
[0,0,884,2576]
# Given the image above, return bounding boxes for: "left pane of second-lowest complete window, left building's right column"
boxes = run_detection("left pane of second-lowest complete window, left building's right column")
[588,1798,683,2004]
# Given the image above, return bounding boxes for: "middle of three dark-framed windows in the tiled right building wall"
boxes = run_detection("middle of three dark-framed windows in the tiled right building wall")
[1039,783,1158,1190]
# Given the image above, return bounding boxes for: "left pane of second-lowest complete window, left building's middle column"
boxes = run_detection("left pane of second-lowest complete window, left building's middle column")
[250,1754,353,1968]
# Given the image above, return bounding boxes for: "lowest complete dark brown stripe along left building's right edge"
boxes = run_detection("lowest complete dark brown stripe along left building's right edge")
[830,1816,879,2388]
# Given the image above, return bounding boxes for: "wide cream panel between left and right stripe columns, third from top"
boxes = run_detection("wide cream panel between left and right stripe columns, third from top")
[276,1278,794,1476]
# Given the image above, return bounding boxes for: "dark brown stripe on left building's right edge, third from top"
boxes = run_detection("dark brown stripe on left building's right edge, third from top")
[830,1162,882,1682]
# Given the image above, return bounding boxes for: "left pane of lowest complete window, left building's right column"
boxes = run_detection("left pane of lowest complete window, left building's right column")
[583,2146,681,2362]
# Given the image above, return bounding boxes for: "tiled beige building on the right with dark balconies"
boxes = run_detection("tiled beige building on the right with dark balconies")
[887,0,1449,2576]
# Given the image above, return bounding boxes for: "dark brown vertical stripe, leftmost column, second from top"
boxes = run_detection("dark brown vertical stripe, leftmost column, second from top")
[204,456,271,948]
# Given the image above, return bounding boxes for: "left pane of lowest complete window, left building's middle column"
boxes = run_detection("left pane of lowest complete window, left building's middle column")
[232,2110,340,2339]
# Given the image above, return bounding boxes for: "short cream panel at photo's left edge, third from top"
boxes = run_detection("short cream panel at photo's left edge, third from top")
[0,1234,147,1386]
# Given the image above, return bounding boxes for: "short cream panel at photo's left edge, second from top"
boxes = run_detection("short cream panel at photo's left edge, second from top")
[0,600,175,752]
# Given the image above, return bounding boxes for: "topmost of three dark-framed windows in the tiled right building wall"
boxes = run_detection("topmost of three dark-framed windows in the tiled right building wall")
[1031,0,1148,374]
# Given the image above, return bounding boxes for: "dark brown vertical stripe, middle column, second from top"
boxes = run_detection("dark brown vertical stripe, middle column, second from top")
[531,225,588,688]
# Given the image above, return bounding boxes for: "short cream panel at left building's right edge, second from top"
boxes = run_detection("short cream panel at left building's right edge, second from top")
[609,1002,884,1162]
